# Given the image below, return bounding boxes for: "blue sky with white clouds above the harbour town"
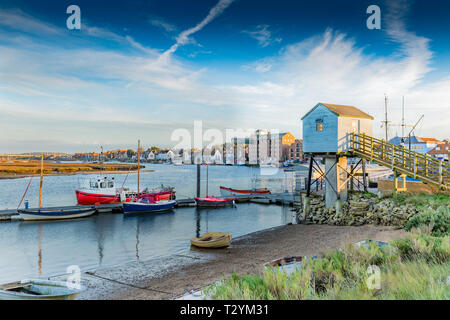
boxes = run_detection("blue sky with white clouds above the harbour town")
[0,0,450,153]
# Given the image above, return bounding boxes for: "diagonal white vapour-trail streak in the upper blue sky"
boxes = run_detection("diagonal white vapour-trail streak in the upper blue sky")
[161,0,234,61]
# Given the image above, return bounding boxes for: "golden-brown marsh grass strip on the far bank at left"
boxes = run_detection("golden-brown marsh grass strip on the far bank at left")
[0,160,137,175]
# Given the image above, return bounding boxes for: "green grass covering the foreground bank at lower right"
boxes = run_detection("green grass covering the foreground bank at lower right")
[207,230,450,300]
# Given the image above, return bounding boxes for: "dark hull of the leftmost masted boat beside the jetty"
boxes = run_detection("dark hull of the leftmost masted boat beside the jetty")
[17,207,96,221]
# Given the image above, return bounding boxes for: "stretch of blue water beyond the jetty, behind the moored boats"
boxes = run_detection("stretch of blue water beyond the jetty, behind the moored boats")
[0,164,296,210]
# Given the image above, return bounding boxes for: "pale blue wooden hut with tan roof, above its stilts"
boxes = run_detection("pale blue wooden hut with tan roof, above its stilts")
[302,103,374,154]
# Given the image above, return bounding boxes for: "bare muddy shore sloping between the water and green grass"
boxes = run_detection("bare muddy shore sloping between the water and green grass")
[50,224,405,300]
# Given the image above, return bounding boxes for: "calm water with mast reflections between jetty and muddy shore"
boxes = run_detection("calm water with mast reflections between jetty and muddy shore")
[0,203,292,283]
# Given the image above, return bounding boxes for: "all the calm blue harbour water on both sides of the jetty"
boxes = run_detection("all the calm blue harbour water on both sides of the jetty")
[0,165,292,283]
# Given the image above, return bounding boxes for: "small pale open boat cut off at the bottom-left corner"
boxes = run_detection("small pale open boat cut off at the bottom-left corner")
[0,280,83,300]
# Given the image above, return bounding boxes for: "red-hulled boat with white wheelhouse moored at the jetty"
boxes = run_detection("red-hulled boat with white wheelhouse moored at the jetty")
[75,177,175,205]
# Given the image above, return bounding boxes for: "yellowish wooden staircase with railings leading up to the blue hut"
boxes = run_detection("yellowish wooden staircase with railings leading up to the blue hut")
[350,133,450,190]
